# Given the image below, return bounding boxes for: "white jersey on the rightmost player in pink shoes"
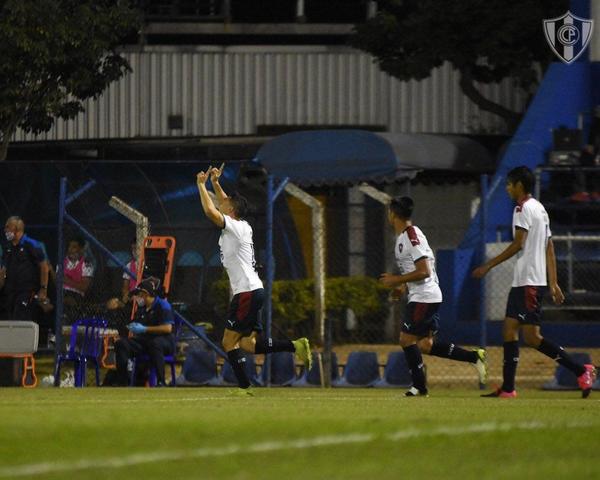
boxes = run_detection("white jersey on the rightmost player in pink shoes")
[512,197,552,287]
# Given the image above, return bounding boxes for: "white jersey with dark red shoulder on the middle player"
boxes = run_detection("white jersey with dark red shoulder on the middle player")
[395,225,442,303]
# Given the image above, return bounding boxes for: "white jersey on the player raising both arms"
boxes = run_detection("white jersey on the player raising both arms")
[219,215,263,295]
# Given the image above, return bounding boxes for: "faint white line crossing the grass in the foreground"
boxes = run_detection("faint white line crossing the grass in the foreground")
[0,422,594,478]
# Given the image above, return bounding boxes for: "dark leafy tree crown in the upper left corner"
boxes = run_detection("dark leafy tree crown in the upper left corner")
[0,0,140,160]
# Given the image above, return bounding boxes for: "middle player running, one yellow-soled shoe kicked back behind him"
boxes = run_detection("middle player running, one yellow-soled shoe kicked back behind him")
[380,197,487,397]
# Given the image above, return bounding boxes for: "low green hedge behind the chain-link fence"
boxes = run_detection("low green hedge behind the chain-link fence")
[210,277,389,326]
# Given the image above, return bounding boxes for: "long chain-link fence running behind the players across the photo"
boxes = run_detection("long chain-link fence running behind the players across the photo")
[0,162,600,388]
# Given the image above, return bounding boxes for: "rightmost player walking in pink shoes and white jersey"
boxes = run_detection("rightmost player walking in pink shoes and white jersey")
[473,166,596,398]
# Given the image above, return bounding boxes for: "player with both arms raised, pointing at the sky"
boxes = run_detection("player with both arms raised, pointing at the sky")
[196,166,312,396]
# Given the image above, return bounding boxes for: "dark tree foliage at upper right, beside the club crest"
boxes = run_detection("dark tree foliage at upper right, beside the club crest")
[351,0,569,128]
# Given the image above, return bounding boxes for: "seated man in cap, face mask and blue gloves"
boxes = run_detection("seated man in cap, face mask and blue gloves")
[115,277,175,387]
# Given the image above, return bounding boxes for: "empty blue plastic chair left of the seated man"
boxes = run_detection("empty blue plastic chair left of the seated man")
[54,318,108,387]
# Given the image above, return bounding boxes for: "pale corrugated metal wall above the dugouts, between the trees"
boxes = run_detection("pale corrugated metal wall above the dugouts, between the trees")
[15,46,524,141]
